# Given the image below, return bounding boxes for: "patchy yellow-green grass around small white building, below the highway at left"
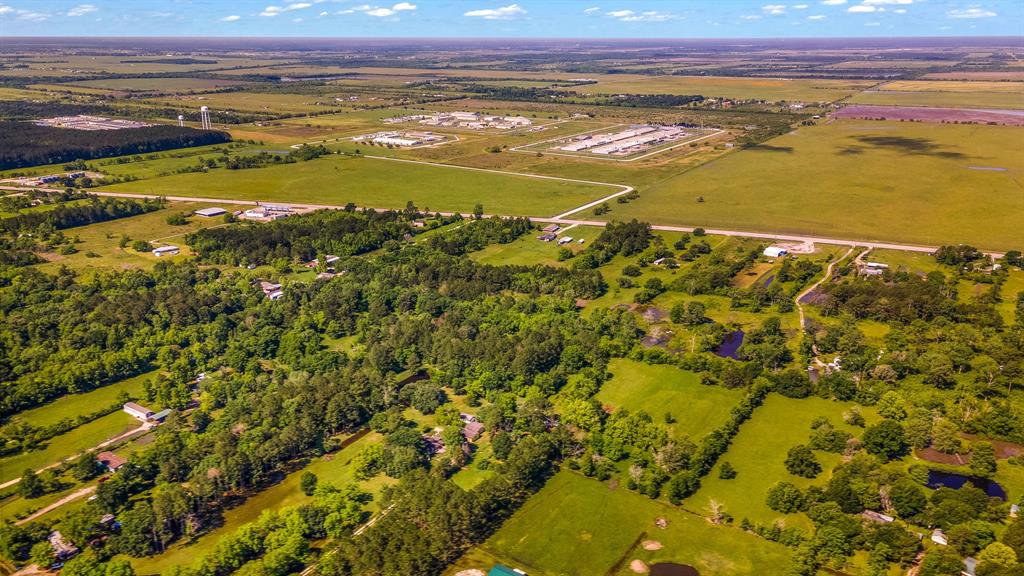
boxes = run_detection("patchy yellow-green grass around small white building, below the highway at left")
[40,202,230,272]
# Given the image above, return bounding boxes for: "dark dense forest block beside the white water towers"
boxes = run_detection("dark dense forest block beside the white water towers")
[0,122,231,169]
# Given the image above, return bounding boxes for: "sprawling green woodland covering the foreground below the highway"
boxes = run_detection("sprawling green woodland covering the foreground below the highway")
[0,206,1024,576]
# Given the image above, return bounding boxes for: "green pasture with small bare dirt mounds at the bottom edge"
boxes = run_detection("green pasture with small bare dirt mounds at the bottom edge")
[449,471,790,576]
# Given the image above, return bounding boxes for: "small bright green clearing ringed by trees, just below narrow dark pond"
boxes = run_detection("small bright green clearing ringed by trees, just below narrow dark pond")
[597,359,742,441]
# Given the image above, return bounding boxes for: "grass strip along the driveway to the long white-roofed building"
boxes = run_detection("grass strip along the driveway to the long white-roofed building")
[0,411,138,482]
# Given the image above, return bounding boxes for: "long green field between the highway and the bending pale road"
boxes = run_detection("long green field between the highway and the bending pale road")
[102,156,620,216]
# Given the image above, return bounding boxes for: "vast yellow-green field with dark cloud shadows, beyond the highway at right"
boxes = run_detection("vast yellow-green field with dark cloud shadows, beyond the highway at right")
[612,121,1024,250]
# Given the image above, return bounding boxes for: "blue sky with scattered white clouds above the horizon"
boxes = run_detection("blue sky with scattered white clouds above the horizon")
[0,0,1024,38]
